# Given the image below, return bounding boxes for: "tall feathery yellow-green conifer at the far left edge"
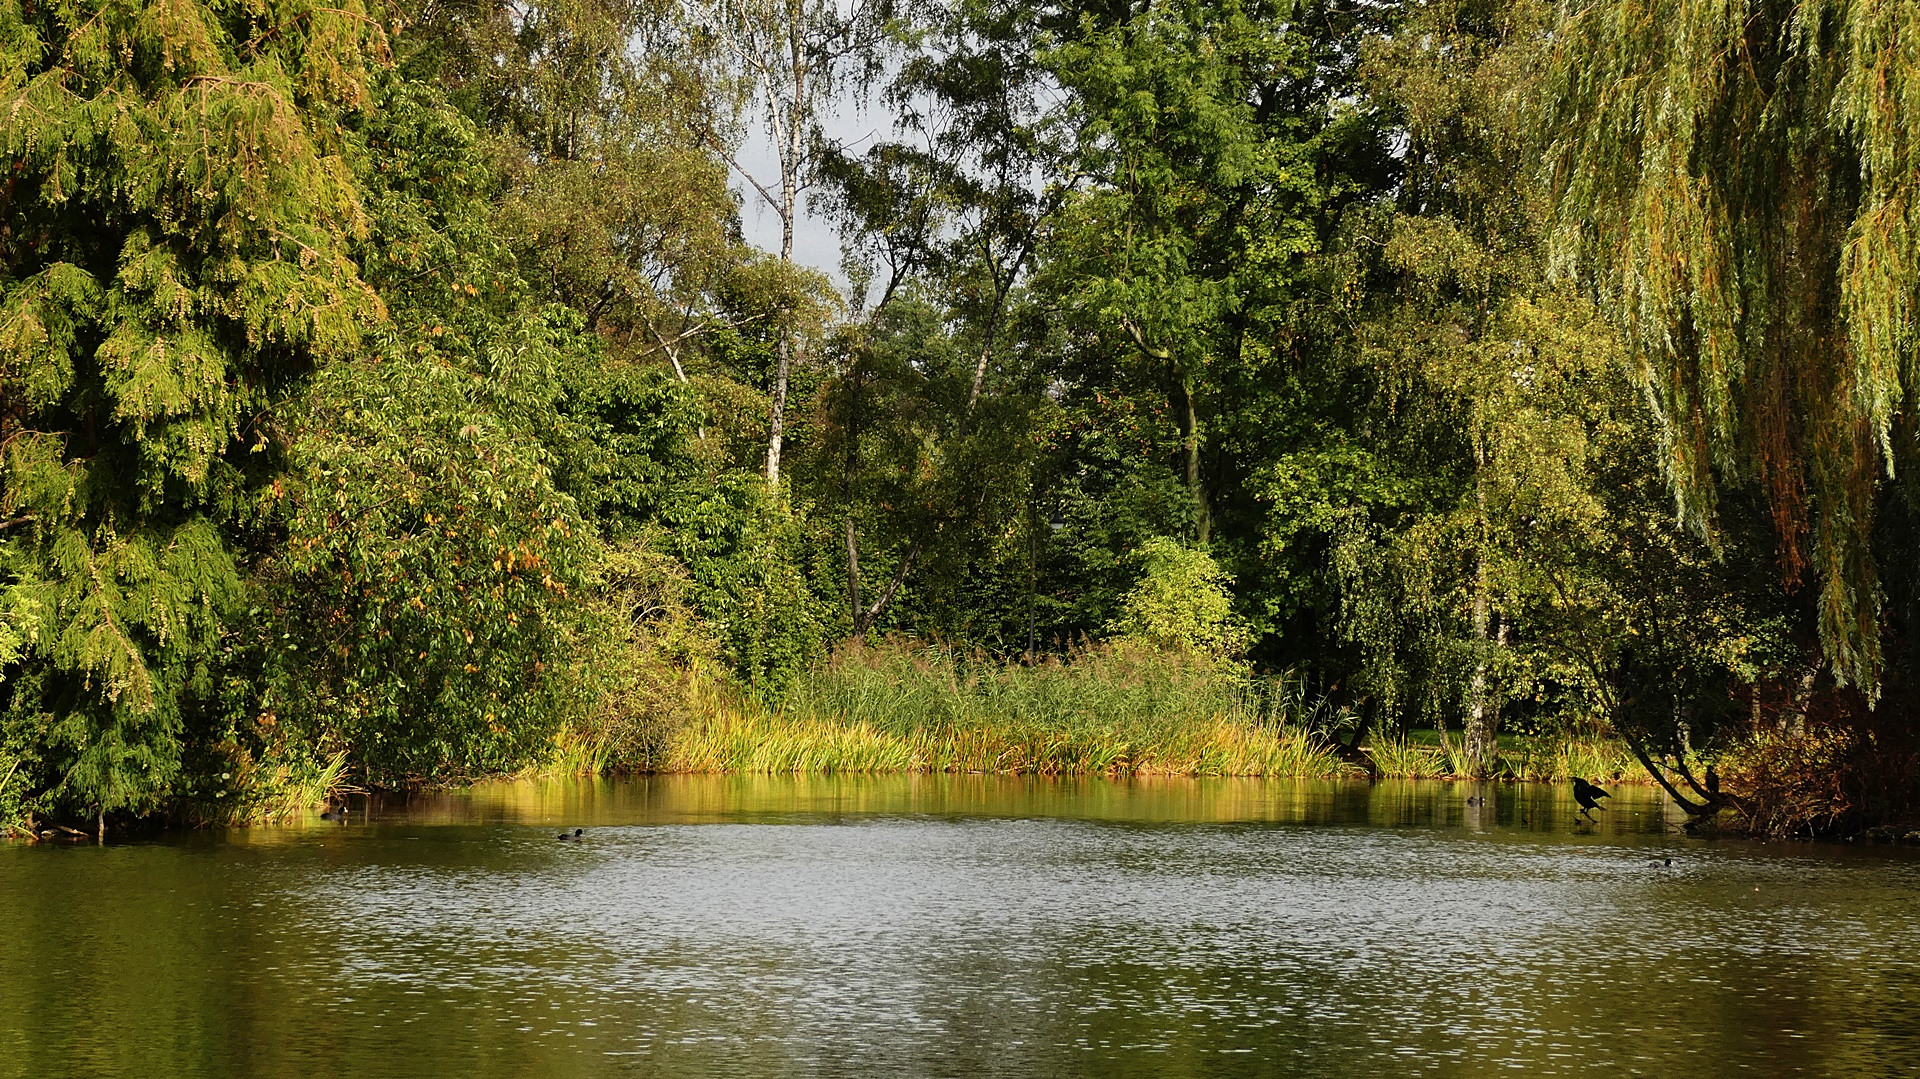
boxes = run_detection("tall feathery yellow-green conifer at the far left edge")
[0,0,386,827]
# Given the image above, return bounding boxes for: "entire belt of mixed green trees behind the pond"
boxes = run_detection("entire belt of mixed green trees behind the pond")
[0,0,1920,831]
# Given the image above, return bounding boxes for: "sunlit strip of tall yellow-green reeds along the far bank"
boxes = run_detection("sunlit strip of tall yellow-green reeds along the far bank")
[657,643,1636,779]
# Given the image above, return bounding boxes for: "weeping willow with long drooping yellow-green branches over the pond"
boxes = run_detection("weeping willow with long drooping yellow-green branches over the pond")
[1548,0,1920,697]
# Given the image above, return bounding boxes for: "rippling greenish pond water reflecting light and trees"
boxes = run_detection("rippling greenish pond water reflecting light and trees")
[0,776,1920,1079]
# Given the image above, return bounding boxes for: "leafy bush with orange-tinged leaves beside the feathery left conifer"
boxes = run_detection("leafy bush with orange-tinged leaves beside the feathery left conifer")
[255,77,601,781]
